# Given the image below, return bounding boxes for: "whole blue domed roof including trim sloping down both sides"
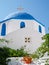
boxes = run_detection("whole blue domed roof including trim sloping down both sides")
[0,13,45,26]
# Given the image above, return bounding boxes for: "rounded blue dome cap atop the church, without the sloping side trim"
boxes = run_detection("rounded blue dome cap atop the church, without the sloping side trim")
[10,13,34,19]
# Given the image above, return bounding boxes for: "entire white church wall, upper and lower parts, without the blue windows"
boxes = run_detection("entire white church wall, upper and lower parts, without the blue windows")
[0,19,45,53]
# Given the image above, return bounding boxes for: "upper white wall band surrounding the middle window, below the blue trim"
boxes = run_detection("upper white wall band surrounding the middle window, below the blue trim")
[6,19,45,35]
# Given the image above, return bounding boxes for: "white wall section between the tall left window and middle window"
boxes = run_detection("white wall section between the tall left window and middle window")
[6,19,25,34]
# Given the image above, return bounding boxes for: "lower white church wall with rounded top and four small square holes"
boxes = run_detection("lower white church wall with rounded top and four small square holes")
[5,28,42,53]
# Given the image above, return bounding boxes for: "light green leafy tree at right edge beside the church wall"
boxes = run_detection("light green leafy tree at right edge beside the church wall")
[42,34,49,55]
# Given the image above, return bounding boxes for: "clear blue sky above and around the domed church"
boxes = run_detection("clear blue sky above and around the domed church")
[0,0,49,33]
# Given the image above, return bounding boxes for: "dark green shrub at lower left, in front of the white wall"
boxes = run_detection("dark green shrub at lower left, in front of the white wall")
[0,47,29,65]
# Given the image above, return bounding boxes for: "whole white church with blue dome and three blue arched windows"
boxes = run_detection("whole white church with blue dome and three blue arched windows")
[0,12,45,53]
